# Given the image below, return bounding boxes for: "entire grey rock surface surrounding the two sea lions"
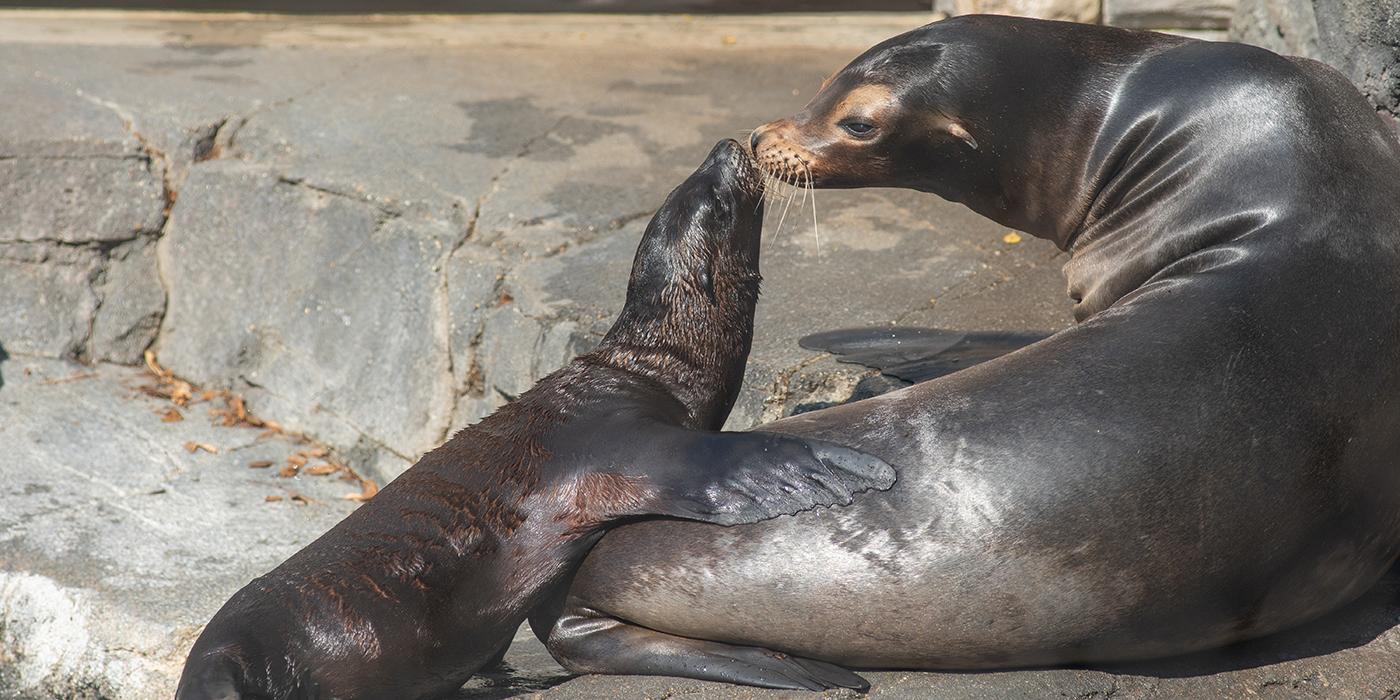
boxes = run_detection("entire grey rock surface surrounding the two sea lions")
[0,13,1400,699]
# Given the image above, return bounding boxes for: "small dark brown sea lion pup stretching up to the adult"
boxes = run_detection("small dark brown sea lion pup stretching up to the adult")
[176,140,895,700]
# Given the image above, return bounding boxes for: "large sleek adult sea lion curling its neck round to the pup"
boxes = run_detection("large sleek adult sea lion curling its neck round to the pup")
[531,17,1400,685]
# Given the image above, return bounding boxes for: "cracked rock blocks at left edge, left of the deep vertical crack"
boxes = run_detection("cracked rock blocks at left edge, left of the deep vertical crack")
[0,70,165,363]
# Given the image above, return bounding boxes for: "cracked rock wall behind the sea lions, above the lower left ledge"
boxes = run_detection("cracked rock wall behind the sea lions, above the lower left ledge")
[0,41,1067,487]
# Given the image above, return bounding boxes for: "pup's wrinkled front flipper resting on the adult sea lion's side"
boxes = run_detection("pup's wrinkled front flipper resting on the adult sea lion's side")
[631,424,895,525]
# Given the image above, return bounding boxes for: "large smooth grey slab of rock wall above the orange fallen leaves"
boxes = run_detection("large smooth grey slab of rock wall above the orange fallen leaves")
[158,162,452,481]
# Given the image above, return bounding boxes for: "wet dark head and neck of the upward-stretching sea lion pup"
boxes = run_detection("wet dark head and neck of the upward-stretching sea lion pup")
[599,139,763,428]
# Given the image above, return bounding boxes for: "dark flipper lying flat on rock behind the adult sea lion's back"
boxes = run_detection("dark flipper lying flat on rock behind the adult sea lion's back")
[798,326,1050,384]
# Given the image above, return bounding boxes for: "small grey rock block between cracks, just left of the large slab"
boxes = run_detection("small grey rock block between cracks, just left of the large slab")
[90,237,165,364]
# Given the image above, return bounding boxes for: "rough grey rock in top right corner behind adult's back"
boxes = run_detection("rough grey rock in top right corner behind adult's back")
[1231,0,1400,129]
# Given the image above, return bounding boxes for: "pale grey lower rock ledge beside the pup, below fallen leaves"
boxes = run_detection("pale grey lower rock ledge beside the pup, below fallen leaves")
[0,358,357,700]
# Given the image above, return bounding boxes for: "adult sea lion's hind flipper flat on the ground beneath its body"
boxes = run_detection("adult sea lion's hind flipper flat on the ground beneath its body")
[531,608,869,692]
